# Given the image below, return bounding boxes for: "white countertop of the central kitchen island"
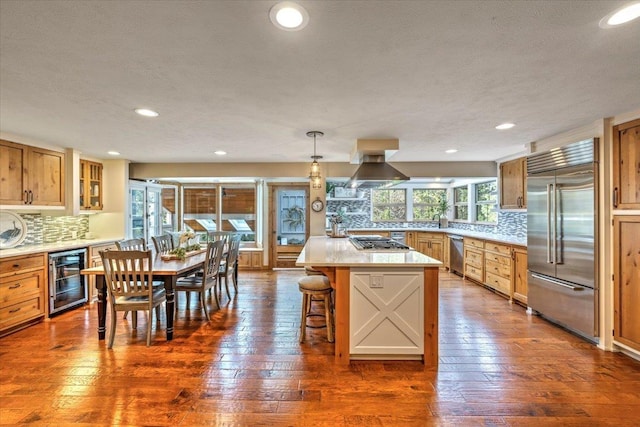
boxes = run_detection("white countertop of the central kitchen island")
[296,236,442,267]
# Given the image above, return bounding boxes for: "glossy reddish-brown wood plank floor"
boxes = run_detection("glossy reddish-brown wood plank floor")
[0,271,640,426]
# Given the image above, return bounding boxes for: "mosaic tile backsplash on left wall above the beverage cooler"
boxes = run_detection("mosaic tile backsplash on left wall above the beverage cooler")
[13,214,89,247]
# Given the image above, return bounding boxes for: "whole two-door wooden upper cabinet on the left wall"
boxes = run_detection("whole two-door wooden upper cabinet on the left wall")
[0,140,65,206]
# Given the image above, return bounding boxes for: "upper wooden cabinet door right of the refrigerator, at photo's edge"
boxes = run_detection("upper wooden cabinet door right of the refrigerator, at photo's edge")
[613,119,640,209]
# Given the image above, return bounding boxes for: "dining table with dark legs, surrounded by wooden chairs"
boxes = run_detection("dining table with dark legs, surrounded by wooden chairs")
[81,249,207,341]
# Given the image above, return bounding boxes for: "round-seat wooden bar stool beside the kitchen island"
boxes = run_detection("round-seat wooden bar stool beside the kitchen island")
[298,274,333,342]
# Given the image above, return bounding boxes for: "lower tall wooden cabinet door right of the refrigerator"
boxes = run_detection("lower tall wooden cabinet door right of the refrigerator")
[613,215,640,350]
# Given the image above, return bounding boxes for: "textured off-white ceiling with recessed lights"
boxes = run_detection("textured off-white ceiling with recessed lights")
[0,0,640,162]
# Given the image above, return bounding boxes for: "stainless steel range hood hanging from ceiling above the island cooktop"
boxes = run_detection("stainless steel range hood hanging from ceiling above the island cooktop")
[347,139,409,188]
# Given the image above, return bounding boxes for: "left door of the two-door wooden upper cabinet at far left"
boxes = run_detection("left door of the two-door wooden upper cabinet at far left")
[0,140,28,205]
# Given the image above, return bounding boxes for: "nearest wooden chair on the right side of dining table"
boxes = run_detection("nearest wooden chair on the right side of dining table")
[175,240,224,320]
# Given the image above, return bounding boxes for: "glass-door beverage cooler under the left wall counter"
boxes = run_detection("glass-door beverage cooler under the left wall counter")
[49,248,87,315]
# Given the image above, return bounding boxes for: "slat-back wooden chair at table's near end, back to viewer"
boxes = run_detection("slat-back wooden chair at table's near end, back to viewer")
[100,250,166,348]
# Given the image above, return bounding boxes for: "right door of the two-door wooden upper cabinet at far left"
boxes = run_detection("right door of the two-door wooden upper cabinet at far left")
[27,147,65,206]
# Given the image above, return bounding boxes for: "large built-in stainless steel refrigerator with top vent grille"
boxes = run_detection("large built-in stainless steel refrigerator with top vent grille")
[527,139,599,342]
